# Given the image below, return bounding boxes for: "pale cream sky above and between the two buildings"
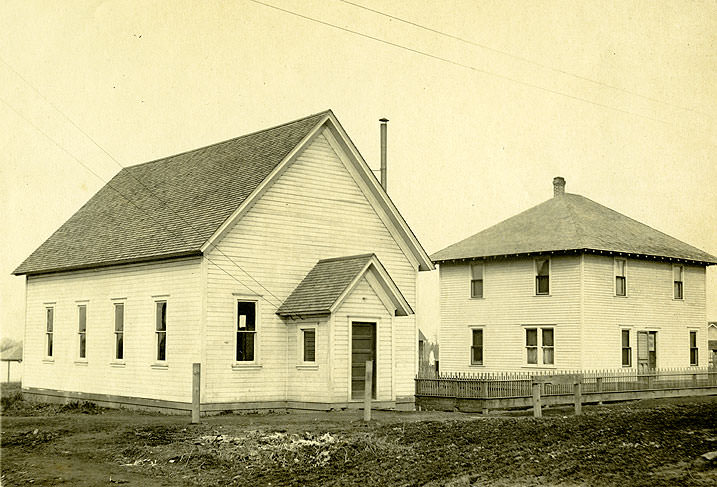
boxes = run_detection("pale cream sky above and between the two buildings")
[0,0,717,344]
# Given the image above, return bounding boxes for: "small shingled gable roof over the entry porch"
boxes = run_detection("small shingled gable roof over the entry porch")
[276,254,413,317]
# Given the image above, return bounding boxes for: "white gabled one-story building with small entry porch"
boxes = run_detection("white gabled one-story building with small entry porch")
[14,111,433,411]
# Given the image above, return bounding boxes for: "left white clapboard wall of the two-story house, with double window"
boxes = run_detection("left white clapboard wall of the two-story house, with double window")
[439,256,580,372]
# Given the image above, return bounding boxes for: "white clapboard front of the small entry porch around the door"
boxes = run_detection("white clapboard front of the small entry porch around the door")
[332,278,394,402]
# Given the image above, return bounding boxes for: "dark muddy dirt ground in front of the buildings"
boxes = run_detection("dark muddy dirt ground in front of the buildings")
[0,388,717,487]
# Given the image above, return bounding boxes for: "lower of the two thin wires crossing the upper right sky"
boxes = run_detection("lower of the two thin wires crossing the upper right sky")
[248,0,704,133]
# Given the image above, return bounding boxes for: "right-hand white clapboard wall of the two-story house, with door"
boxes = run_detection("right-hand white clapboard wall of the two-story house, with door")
[583,255,708,368]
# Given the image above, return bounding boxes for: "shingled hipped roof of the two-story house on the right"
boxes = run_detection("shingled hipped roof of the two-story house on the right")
[431,193,717,265]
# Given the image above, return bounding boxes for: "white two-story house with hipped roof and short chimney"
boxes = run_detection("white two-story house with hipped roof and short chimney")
[431,177,717,372]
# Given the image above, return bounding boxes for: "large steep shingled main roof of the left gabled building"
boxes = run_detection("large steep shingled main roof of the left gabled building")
[13,110,433,275]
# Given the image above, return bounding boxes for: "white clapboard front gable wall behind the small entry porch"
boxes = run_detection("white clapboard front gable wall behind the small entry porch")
[205,129,417,402]
